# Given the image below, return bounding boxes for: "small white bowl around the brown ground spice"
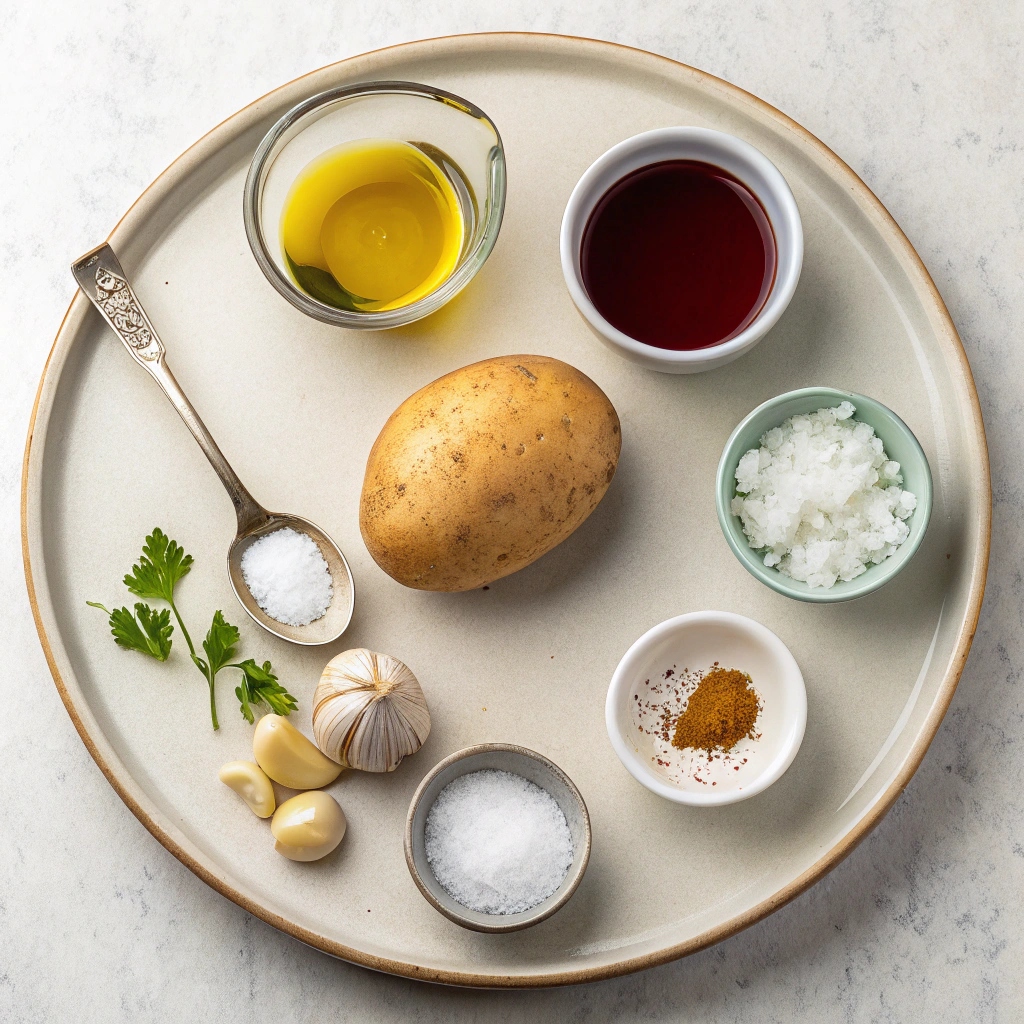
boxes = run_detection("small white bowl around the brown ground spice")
[604,611,807,807]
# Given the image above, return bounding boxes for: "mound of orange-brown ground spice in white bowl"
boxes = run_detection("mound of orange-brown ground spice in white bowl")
[672,666,761,756]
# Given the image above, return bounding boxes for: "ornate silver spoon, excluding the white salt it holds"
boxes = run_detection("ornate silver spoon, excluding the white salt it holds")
[72,245,355,645]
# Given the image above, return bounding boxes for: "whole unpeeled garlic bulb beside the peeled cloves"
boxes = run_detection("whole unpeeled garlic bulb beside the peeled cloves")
[313,647,430,771]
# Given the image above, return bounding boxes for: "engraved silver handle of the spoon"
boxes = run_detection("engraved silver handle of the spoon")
[72,244,269,535]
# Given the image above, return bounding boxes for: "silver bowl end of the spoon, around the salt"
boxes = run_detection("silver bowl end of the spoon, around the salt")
[227,512,355,647]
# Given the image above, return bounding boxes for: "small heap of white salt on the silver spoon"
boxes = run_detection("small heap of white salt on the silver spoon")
[242,526,334,626]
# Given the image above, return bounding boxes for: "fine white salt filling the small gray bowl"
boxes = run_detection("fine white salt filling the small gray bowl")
[424,768,572,914]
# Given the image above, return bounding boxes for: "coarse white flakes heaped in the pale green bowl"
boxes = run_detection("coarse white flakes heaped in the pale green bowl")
[732,401,918,589]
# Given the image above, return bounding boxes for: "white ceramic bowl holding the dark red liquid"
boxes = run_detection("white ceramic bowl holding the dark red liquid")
[559,127,804,374]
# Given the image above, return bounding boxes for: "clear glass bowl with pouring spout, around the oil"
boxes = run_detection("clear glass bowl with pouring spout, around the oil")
[244,82,505,331]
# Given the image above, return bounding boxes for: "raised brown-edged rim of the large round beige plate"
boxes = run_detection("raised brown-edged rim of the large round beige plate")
[20,32,992,988]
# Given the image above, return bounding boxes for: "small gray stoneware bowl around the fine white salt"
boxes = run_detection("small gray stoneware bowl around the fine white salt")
[406,743,591,932]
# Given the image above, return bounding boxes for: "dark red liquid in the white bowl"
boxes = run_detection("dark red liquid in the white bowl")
[580,160,776,351]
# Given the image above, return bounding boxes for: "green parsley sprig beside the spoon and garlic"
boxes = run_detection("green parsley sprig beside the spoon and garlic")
[86,527,297,729]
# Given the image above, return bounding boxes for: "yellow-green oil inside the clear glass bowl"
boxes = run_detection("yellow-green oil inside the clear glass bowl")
[281,139,465,311]
